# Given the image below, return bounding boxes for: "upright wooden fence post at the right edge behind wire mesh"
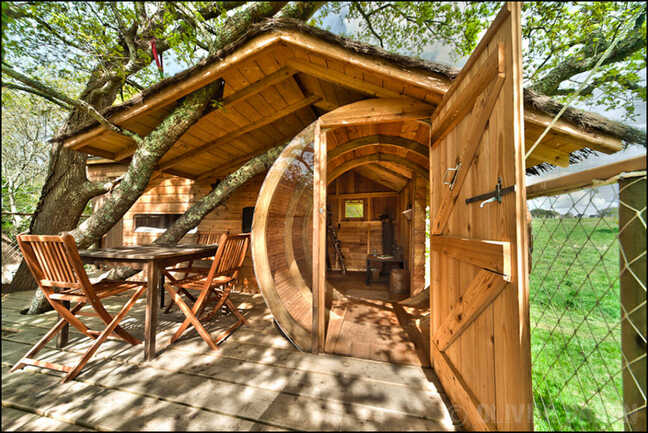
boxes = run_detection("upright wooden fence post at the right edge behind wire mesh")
[619,172,646,431]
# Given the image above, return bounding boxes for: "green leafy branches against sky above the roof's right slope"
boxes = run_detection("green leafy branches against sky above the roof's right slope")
[317,2,646,120]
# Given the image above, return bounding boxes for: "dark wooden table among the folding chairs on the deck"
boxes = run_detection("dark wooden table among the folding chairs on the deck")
[79,245,218,361]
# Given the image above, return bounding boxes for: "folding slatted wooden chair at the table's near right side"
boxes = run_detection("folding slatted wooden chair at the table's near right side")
[165,234,250,350]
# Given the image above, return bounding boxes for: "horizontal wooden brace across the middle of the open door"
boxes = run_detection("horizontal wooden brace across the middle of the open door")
[430,236,511,279]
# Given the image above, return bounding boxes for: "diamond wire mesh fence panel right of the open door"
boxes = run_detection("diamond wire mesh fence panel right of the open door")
[527,172,646,430]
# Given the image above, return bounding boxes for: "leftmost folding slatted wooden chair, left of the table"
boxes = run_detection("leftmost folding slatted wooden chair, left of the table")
[11,233,146,382]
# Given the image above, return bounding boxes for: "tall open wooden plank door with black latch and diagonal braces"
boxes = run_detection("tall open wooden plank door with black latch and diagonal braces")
[430,3,533,430]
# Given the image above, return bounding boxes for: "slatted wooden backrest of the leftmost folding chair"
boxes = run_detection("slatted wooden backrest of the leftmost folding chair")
[16,233,94,296]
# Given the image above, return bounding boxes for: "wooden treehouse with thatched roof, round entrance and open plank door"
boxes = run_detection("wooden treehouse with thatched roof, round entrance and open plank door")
[67,4,622,429]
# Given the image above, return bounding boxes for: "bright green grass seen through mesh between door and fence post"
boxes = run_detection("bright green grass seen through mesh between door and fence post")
[530,217,623,431]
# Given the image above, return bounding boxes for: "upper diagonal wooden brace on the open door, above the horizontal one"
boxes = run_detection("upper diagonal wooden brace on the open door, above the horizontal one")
[430,75,504,235]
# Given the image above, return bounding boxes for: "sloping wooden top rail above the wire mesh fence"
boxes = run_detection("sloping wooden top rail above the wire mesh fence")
[526,155,646,199]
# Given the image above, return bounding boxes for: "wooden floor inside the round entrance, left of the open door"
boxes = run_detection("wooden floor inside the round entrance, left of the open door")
[325,272,430,366]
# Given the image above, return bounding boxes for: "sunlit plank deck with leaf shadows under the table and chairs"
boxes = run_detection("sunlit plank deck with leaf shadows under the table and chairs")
[2,286,459,431]
